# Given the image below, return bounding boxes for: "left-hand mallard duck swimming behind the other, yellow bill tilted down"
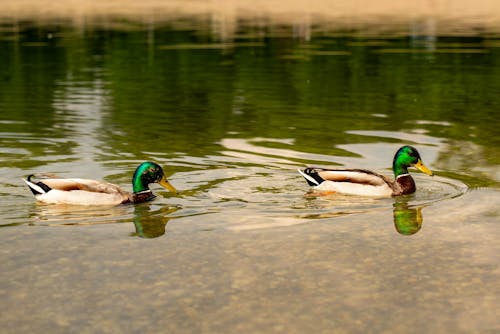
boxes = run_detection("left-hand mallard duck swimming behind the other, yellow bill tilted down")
[23,161,176,205]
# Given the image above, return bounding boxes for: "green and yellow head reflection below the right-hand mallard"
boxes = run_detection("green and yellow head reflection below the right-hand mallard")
[393,199,423,235]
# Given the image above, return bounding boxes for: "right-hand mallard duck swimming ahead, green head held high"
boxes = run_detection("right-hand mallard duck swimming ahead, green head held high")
[299,146,433,197]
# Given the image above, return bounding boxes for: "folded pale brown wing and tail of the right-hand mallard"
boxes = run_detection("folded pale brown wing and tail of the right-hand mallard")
[299,167,392,186]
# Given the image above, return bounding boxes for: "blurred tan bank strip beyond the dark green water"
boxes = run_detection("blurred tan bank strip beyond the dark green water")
[0,0,500,37]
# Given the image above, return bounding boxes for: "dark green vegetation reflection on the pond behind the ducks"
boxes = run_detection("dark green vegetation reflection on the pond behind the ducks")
[0,21,500,180]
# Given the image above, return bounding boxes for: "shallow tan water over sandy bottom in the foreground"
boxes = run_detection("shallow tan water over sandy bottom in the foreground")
[0,189,500,333]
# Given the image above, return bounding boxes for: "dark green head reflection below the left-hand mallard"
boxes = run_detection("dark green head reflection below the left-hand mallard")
[131,203,179,238]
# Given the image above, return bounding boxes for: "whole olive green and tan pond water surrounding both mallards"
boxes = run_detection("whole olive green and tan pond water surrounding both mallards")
[0,20,500,333]
